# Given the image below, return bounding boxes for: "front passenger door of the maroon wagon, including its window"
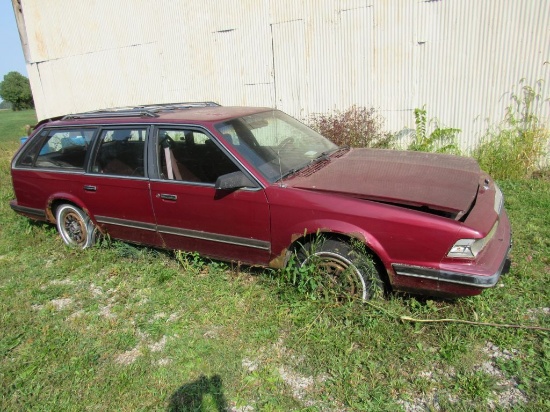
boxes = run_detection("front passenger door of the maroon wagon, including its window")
[151,127,271,264]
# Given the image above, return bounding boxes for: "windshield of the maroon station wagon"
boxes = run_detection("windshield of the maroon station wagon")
[216,110,338,182]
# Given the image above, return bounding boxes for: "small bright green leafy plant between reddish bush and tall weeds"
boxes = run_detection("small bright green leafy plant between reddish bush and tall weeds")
[407,106,460,155]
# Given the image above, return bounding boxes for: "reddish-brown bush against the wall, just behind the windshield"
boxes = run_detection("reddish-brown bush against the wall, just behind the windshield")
[309,105,395,148]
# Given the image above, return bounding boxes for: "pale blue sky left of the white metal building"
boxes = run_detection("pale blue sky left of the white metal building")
[0,0,29,81]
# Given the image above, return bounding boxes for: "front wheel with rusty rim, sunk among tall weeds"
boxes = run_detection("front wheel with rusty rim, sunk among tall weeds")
[296,238,384,301]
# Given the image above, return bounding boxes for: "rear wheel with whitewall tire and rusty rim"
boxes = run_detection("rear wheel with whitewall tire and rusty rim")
[55,203,96,249]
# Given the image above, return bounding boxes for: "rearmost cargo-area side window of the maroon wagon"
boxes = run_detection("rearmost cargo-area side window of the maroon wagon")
[32,129,95,169]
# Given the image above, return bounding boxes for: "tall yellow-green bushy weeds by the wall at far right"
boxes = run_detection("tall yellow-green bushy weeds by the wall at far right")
[472,80,550,179]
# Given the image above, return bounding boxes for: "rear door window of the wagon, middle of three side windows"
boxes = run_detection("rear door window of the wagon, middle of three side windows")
[92,128,147,177]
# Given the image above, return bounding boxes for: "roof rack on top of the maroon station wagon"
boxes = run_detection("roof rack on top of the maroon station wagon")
[61,102,220,120]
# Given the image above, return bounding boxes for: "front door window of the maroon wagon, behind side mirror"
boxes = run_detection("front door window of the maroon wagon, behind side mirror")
[157,129,239,184]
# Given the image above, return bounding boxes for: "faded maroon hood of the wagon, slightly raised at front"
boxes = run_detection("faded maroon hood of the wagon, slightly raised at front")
[285,149,480,215]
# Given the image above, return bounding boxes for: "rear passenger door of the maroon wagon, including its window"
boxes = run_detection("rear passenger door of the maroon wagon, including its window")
[81,126,162,246]
